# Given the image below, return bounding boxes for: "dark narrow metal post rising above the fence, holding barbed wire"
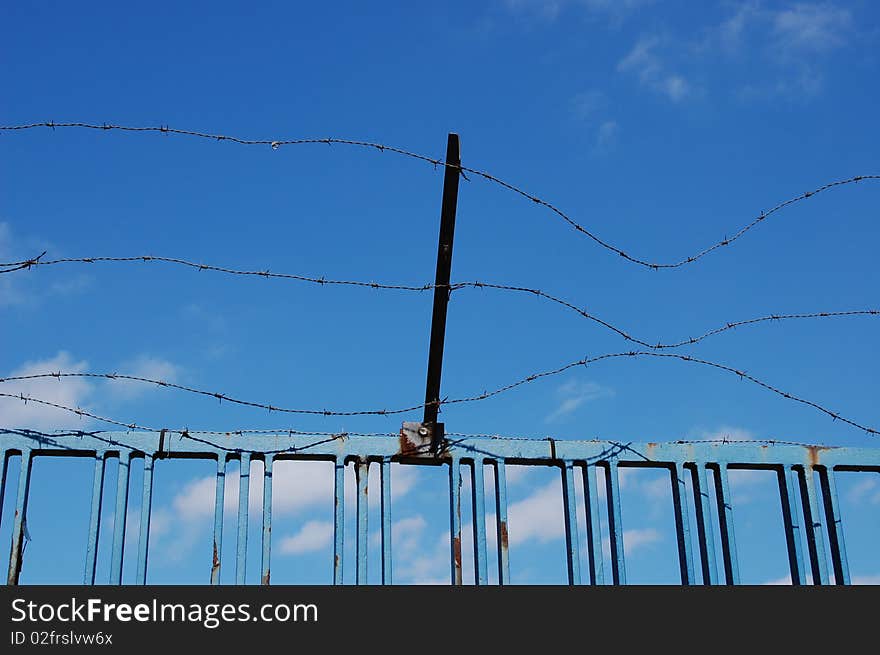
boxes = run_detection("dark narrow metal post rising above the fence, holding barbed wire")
[424,134,461,452]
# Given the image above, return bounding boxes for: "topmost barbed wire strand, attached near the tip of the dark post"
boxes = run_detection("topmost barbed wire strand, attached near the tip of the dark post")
[0,121,880,270]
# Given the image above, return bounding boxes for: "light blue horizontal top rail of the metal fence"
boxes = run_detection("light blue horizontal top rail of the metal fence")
[0,430,880,470]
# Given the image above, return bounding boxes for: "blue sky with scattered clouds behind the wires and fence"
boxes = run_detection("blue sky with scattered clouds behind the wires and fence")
[0,0,880,583]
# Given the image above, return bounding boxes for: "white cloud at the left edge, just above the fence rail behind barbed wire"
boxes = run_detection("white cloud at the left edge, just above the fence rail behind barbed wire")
[0,351,94,430]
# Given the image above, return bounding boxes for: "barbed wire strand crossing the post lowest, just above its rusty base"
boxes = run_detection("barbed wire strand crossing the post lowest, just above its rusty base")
[0,351,878,435]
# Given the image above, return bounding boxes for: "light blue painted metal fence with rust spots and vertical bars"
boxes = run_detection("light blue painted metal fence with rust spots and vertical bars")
[0,429,880,585]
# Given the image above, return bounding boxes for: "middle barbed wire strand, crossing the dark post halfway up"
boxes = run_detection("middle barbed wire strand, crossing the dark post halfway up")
[0,252,880,350]
